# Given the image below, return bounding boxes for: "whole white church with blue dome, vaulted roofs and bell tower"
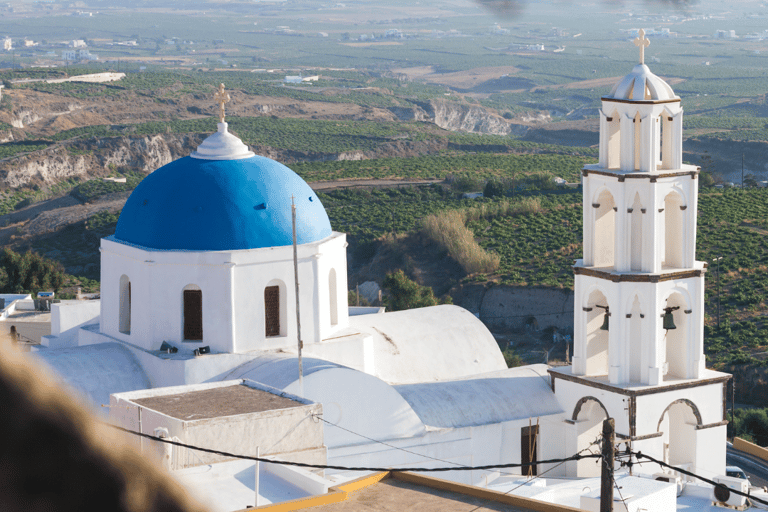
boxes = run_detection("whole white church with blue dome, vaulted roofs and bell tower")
[31,34,730,510]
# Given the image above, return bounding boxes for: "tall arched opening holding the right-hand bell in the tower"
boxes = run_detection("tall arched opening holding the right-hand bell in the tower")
[660,292,690,380]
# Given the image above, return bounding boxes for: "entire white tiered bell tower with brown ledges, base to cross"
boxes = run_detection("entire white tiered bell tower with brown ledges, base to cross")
[550,30,730,476]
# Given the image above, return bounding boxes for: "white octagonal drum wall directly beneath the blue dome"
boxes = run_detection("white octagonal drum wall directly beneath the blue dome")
[101,233,348,352]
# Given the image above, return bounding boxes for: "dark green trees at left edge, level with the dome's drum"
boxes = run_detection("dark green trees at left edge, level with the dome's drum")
[0,248,64,294]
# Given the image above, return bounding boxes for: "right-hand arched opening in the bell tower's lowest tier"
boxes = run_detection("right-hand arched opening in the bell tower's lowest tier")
[657,399,701,468]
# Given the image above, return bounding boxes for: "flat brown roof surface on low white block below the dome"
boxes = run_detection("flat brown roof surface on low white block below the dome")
[132,384,306,420]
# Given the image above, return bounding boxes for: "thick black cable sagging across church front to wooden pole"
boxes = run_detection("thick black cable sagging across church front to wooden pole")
[107,423,600,473]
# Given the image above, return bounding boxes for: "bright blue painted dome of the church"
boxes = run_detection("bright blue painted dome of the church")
[115,156,331,251]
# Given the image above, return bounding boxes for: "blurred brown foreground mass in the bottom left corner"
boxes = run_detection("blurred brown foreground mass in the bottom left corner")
[0,337,204,512]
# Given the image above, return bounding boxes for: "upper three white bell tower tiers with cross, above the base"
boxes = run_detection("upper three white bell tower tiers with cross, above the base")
[573,28,705,385]
